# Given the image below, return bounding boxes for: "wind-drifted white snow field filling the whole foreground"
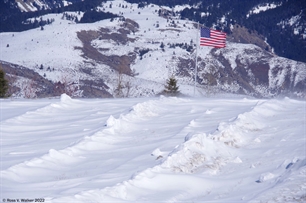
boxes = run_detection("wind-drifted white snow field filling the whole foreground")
[0,95,306,202]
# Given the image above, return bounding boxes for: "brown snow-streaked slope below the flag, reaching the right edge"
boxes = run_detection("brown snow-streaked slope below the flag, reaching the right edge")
[177,45,306,97]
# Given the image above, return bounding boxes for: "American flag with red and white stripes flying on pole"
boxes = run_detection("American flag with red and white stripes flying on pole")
[200,27,226,48]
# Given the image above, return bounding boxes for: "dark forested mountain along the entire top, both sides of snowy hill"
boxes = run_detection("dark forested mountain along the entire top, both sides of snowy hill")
[0,0,306,62]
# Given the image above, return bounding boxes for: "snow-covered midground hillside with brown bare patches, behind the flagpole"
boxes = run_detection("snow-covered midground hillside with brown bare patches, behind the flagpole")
[0,0,306,97]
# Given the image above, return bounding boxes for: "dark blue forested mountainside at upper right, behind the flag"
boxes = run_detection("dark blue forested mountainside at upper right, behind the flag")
[136,0,306,62]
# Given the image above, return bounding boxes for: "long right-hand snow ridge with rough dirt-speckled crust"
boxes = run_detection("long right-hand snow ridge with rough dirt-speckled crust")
[70,98,305,202]
